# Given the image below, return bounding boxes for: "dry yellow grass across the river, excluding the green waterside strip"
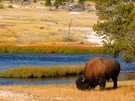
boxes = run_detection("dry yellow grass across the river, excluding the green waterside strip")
[0,1,97,45]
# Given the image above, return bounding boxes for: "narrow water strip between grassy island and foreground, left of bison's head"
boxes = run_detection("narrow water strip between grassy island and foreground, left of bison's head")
[0,77,76,85]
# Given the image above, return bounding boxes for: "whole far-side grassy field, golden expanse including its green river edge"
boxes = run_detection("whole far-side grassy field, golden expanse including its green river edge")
[0,1,103,54]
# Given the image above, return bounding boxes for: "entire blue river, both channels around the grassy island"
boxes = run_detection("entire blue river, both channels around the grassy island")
[0,53,135,85]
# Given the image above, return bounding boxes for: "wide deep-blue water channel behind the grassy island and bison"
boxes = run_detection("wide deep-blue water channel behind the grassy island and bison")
[0,54,135,71]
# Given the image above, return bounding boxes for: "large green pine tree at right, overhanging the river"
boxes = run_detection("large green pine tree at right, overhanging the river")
[93,0,135,62]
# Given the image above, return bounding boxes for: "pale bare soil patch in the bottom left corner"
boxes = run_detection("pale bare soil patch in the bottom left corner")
[0,90,74,101]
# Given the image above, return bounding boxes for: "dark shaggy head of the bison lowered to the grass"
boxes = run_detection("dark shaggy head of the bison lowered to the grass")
[76,76,96,90]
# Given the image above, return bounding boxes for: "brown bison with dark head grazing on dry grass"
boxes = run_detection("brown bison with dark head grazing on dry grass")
[76,57,120,90]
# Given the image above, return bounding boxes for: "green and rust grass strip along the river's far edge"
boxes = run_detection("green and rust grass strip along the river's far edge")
[0,46,104,54]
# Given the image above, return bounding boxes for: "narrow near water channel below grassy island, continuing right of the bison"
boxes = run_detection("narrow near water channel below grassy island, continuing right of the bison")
[0,73,135,85]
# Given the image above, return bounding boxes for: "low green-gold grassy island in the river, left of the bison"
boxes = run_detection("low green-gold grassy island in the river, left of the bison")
[0,65,84,78]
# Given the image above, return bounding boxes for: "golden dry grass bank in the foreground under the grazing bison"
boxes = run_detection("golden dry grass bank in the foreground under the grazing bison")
[0,80,135,101]
